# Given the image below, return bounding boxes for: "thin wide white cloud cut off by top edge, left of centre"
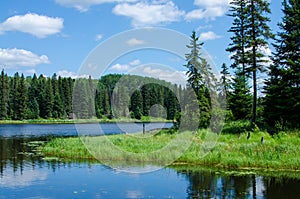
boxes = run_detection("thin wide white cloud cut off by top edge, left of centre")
[55,0,137,12]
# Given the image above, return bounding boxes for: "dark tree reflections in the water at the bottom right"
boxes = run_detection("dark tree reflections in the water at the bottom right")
[179,171,300,199]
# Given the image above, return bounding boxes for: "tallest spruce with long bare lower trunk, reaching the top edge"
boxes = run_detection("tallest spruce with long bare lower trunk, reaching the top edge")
[227,0,273,125]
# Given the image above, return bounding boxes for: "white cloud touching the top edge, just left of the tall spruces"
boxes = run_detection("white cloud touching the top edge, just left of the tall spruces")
[185,0,232,21]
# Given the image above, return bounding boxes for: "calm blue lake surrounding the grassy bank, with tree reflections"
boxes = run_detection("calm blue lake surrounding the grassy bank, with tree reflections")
[0,123,300,199]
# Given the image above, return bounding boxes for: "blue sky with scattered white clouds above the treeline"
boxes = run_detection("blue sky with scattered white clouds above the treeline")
[0,0,282,81]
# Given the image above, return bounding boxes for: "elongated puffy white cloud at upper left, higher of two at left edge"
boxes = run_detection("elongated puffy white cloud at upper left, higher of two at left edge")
[0,13,64,38]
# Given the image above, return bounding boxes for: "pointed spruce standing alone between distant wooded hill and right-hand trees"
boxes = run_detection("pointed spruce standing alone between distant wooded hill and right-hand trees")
[185,31,212,128]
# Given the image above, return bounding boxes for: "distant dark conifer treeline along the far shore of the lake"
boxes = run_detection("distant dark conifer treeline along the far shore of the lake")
[0,70,184,120]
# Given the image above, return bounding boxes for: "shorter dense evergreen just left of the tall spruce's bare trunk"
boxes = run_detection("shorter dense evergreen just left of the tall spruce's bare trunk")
[228,68,251,120]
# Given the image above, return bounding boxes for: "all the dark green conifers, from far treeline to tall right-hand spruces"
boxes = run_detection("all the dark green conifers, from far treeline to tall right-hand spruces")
[0,0,300,132]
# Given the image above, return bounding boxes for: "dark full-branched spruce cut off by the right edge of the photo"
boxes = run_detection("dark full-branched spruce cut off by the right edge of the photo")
[264,0,300,128]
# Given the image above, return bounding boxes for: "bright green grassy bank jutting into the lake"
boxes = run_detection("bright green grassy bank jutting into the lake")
[41,131,300,171]
